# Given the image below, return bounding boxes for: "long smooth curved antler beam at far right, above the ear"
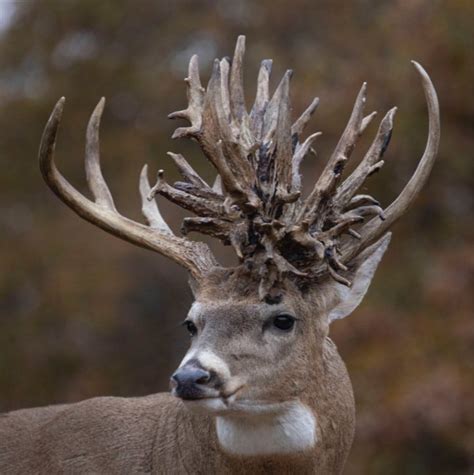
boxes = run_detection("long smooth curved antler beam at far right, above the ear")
[342,61,440,262]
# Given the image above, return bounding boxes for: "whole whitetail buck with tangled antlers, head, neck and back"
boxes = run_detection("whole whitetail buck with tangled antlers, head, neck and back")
[0,37,440,474]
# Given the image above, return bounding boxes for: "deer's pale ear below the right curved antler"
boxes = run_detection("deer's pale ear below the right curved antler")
[328,233,392,323]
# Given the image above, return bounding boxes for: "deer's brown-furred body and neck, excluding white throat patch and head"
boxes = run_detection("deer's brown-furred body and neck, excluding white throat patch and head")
[0,339,354,474]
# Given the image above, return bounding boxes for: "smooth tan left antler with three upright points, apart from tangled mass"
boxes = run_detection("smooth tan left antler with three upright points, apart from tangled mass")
[39,98,217,279]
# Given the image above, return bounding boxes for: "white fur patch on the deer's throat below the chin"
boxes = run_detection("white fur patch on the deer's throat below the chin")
[216,402,317,456]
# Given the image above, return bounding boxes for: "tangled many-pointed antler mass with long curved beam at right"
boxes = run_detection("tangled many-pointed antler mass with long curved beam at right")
[163,36,439,294]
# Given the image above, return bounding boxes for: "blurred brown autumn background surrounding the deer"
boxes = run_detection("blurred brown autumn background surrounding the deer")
[0,0,474,475]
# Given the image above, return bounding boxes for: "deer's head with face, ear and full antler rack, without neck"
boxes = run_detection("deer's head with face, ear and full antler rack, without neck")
[39,36,440,454]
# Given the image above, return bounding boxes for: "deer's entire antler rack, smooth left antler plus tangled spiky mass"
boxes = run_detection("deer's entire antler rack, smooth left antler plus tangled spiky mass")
[40,36,439,297]
